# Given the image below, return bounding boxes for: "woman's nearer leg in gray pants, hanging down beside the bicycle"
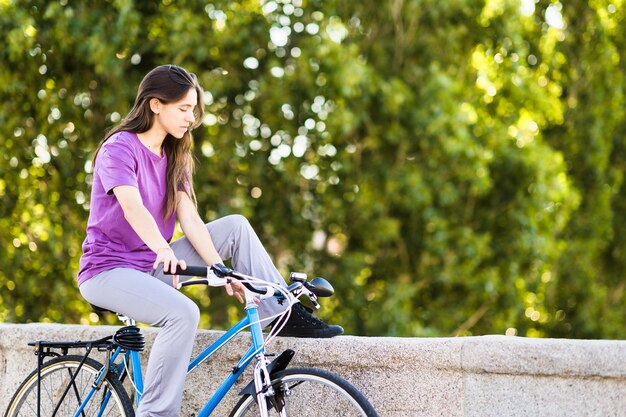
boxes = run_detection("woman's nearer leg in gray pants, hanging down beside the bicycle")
[80,268,200,417]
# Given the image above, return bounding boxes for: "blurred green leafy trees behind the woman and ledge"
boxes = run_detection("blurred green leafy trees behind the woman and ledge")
[0,0,626,338]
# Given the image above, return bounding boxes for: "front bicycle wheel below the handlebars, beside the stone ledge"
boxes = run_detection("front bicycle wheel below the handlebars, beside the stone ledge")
[230,368,378,417]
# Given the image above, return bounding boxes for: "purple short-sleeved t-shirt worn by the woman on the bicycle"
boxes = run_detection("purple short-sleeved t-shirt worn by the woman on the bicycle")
[78,132,176,285]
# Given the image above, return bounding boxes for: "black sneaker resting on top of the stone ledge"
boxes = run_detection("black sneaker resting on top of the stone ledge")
[272,303,343,339]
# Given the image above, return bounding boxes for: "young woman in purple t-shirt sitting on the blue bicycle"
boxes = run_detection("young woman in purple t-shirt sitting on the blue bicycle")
[78,65,343,417]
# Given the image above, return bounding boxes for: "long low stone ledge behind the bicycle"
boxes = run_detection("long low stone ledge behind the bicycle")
[0,324,626,417]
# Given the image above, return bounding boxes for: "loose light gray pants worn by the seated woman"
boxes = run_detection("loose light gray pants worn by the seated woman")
[80,215,286,417]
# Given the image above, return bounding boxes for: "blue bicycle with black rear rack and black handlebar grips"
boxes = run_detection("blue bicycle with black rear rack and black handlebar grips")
[5,266,378,417]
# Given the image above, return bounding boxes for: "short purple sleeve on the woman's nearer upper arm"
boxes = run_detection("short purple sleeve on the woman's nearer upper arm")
[96,140,138,194]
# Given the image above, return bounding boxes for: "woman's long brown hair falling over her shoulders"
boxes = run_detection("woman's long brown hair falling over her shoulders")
[92,65,204,218]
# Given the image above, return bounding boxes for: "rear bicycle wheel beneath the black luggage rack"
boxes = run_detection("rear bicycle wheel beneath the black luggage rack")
[4,355,135,417]
